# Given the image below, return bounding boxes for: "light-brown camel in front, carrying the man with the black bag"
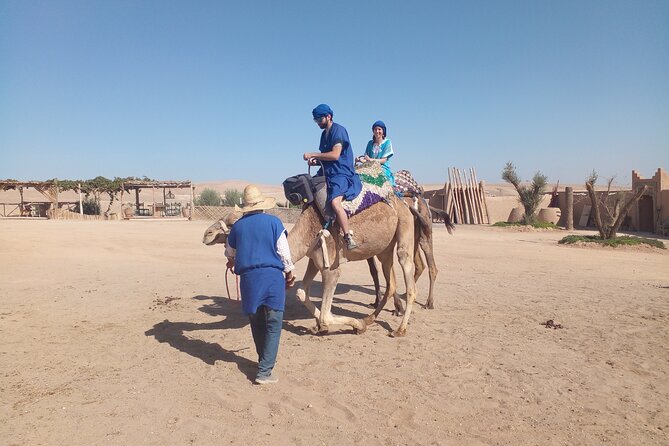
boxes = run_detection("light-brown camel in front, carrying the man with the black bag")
[203,195,416,336]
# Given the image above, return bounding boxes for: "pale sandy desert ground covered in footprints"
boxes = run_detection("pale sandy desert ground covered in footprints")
[0,220,669,446]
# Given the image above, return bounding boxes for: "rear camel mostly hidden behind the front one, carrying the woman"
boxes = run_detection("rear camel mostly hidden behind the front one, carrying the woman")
[367,196,455,311]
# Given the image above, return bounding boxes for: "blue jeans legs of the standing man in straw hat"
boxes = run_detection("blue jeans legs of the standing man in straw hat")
[249,305,283,378]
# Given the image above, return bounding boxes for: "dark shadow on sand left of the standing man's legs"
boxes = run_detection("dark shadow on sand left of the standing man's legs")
[144,296,257,381]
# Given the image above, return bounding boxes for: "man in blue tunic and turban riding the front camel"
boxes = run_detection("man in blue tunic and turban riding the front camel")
[303,104,362,250]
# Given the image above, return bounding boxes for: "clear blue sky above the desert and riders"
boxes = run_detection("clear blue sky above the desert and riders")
[0,0,669,184]
